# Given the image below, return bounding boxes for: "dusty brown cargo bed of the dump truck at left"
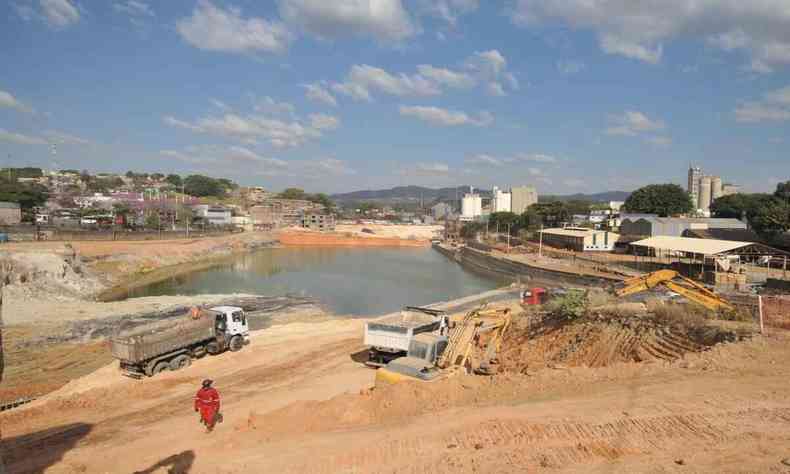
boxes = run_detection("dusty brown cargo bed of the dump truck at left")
[110,313,215,363]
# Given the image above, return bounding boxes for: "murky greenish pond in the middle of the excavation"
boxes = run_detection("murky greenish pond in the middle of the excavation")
[125,247,503,316]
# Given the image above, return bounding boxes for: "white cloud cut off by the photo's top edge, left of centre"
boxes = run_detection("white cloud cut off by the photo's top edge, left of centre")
[279,0,418,42]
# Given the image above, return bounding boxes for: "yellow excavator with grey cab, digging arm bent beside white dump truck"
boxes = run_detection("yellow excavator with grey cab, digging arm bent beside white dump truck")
[376,307,512,386]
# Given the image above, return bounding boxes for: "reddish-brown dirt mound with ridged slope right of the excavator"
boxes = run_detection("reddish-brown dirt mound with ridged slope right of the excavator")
[499,315,742,373]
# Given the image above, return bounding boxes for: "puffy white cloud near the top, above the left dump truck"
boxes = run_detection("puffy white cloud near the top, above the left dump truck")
[176,0,293,53]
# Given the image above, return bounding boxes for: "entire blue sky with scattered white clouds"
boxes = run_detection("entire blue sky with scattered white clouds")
[0,0,790,194]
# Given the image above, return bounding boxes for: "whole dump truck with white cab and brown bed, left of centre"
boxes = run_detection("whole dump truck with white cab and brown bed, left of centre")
[110,306,250,378]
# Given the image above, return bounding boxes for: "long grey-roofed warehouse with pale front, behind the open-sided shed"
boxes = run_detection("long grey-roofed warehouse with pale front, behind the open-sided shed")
[620,214,747,237]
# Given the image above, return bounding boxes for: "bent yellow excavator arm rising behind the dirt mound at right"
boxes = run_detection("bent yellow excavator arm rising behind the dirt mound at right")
[615,270,735,311]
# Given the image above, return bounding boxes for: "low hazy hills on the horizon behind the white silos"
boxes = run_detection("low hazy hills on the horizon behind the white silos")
[331,186,631,204]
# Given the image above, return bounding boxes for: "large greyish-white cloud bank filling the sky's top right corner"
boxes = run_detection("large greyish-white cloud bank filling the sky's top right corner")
[510,0,790,72]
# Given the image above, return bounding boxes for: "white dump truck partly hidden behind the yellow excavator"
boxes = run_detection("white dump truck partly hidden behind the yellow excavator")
[364,306,449,367]
